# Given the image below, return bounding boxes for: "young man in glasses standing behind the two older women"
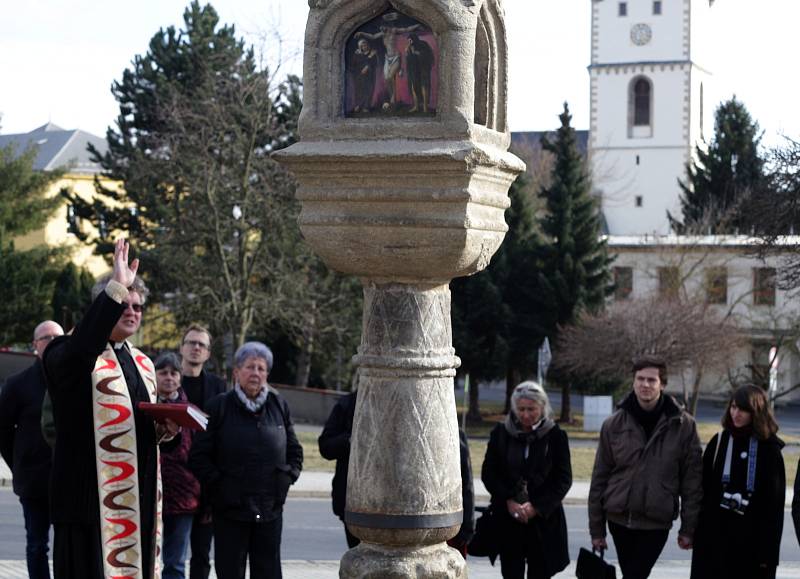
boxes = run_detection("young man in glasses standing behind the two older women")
[181,324,225,579]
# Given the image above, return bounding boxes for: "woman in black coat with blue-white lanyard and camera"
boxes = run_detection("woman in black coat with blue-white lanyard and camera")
[691,385,786,579]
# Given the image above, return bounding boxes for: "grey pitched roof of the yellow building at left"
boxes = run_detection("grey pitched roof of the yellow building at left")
[0,123,108,175]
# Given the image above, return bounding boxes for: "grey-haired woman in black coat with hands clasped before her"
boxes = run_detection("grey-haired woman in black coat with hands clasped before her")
[481,382,572,579]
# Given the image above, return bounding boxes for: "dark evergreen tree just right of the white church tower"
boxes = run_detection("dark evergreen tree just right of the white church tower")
[667,96,765,234]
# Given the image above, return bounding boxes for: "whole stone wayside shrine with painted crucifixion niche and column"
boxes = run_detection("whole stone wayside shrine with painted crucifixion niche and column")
[276,0,525,579]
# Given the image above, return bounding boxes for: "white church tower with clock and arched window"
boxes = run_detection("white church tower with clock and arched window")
[589,0,714,235]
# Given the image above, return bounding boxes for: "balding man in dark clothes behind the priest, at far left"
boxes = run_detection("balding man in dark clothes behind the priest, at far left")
[0,320,64,579]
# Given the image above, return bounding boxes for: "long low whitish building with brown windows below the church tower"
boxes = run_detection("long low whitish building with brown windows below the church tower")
[608,235,800,400]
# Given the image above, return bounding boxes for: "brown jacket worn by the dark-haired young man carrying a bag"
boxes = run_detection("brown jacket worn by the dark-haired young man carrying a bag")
[589,392,703,539]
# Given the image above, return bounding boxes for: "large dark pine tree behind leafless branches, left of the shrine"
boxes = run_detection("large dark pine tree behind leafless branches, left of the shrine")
[65,1,361,382]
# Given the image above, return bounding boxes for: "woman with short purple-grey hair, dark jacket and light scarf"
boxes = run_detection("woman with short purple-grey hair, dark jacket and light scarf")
[190,342,303,579]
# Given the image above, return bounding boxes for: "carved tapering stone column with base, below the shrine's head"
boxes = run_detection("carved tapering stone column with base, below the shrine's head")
[340,282,466,579]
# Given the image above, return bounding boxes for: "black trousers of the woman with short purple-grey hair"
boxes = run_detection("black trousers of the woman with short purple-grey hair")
[214,515,283,579]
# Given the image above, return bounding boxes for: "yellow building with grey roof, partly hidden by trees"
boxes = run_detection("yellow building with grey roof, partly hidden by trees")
[0,123,113,276]
